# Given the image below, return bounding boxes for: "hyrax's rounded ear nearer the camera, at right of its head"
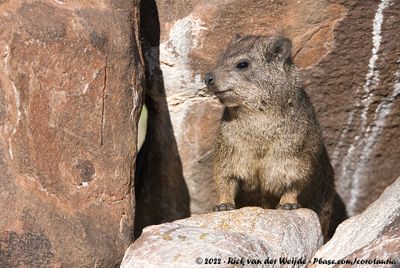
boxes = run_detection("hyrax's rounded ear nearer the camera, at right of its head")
[266,37,292,64]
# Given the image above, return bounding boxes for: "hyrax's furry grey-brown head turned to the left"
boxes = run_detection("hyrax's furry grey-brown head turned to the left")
[204,36,296,110]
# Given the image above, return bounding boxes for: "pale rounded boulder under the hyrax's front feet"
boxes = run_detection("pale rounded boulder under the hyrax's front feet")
[121,207,323,268]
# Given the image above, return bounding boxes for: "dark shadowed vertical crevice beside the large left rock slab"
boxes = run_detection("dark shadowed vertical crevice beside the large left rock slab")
[134,0,190,239]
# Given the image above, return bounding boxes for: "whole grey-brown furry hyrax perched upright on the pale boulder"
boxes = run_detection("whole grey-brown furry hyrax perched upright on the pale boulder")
[205,36,334,238]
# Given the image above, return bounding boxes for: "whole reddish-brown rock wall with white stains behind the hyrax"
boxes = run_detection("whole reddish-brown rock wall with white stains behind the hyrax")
[142,0,400,222]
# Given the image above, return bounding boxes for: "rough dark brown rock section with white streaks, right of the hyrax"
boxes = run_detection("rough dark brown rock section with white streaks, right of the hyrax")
[304,0,400,216]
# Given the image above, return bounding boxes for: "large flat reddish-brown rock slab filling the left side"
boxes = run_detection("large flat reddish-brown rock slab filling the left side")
[0,0,143,267]
